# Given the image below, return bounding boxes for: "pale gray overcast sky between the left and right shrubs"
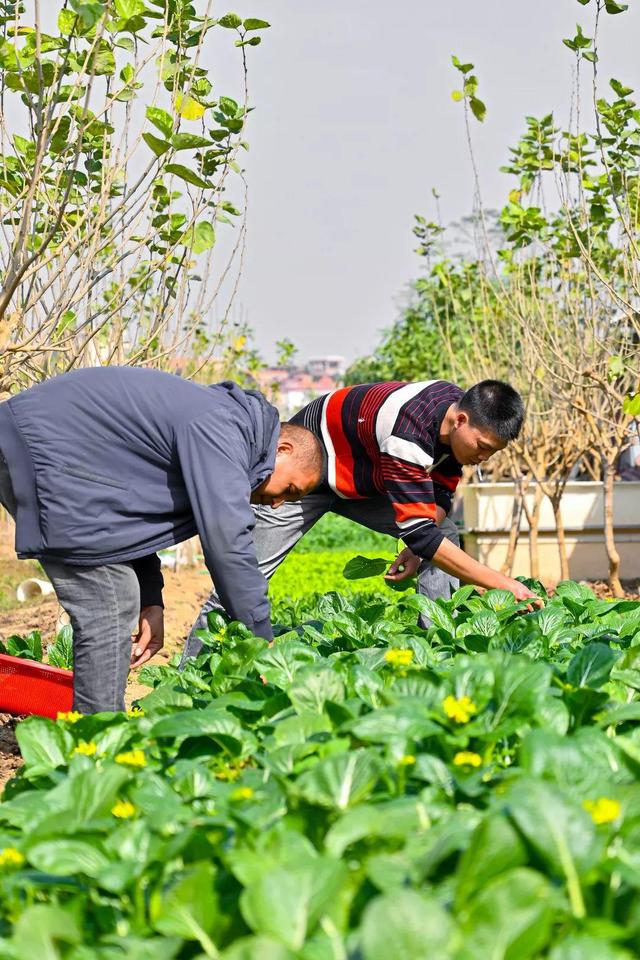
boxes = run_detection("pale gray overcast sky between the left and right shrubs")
[212,0,640,368]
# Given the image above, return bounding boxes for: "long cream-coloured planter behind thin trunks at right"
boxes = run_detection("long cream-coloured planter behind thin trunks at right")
[462,481,640,584]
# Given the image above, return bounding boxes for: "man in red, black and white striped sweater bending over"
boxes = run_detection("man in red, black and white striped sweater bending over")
[185,380,536,657]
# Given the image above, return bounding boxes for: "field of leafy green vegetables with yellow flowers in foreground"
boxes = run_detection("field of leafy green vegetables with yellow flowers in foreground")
[0,582,640,960]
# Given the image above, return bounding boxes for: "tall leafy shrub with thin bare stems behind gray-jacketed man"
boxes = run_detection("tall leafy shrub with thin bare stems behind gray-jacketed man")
[0,0,269,394]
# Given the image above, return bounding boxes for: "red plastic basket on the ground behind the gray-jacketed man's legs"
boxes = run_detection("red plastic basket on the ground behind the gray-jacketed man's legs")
[0,653,73,720]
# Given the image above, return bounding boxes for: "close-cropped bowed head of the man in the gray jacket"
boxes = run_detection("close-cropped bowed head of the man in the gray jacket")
[251,423,324,507]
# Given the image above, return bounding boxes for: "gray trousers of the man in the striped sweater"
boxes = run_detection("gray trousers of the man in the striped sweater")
[181,493,460,666]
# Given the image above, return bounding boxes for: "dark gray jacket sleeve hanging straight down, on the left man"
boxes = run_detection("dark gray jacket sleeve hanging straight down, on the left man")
[176,413,273,640]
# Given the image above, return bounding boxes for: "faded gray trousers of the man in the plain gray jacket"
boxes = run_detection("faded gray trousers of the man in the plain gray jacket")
[0,453,140,713]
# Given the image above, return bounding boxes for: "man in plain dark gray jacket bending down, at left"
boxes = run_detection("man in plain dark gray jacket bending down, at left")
[0,367,323,713]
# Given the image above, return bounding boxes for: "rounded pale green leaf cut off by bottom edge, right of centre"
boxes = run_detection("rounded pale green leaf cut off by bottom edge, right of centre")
[360,890,455,960]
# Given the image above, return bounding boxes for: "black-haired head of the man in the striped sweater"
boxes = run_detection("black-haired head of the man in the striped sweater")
[443,380,524,464]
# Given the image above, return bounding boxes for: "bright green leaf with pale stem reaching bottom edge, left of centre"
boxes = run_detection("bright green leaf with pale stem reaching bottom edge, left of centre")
[149,862,219,958]
